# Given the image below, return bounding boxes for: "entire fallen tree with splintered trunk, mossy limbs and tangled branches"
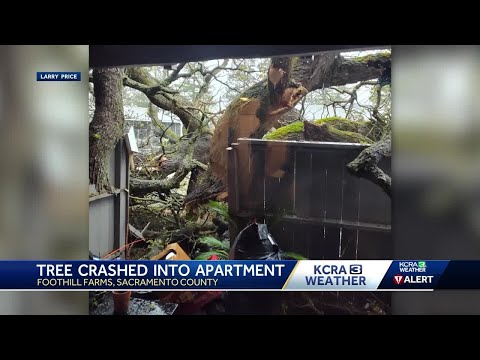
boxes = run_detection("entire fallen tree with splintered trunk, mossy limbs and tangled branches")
[91,53,390,264]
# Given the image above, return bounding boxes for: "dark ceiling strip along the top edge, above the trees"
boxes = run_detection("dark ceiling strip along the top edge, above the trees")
[90,45,386,67]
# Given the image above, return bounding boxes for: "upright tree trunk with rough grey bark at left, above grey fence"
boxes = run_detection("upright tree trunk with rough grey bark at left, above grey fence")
[89,69,124,192]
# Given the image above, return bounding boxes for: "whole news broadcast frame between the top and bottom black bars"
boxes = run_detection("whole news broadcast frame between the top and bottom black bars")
[0,45,480,316]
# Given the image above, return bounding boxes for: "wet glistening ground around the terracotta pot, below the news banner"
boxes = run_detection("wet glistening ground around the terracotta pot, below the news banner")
[90,293,178,315]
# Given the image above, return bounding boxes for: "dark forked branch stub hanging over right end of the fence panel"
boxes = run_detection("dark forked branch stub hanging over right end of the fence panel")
[347,133,392,197]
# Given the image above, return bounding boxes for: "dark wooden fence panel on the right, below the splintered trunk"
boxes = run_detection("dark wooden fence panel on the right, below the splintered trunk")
[229,139,393,260]
